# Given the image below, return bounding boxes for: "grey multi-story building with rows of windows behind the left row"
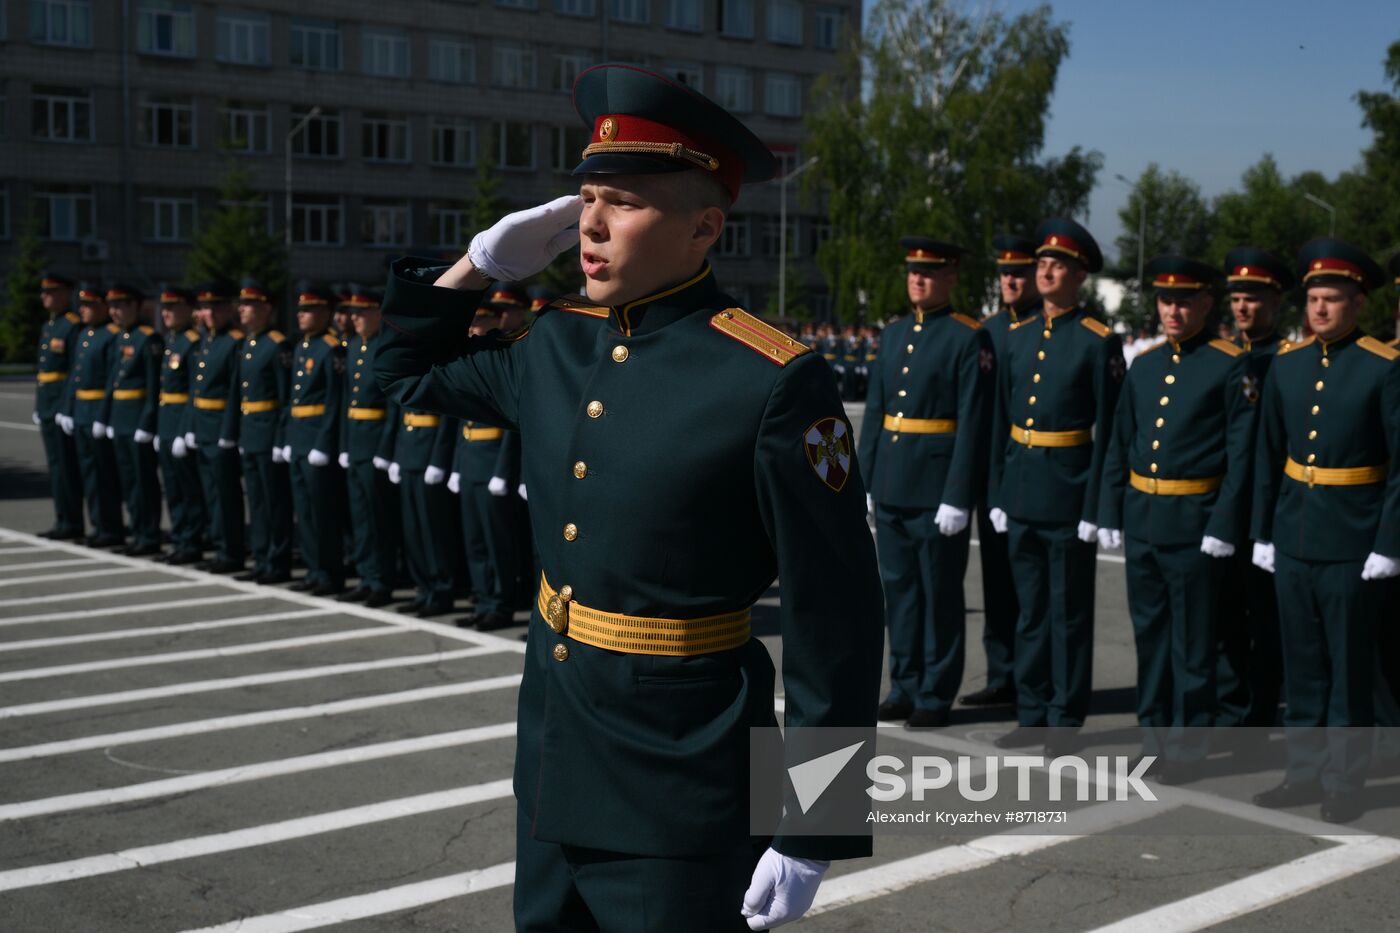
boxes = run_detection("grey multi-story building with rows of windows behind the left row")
[0,0,861,311]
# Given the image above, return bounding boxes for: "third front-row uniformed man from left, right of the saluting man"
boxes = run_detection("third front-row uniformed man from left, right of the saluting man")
[1099,255,1257,783]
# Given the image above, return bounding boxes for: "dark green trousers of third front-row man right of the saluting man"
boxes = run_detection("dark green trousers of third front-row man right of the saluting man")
[1123,535,1225,762]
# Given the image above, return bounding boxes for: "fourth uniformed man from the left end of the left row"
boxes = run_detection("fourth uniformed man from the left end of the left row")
[153,284,209,565]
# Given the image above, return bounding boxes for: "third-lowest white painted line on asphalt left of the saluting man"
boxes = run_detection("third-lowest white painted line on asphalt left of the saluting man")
[0,721,515,821]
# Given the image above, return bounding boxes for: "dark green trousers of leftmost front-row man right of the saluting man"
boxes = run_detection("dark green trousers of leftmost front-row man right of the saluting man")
[875,504,972,712]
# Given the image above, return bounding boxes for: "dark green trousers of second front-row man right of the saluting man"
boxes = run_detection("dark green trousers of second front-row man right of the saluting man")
[1007,518,1098,728]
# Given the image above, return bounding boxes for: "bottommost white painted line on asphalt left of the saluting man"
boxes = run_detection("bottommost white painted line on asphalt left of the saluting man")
[189,862,515,933]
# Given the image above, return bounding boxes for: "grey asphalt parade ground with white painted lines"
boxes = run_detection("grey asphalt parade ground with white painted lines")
[0,381,1400,933]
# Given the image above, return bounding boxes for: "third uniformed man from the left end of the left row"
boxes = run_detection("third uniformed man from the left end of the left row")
[106,283,165,558]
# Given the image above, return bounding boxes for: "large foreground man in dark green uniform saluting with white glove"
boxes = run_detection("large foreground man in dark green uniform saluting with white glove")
[375,66,873,932]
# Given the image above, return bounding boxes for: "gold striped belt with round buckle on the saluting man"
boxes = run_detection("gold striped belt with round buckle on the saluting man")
[539,573,750,656]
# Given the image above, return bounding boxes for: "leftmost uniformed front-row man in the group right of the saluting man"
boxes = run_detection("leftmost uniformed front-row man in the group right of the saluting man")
[860,237,994,728]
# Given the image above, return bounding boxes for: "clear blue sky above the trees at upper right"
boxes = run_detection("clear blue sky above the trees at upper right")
[867,0,1400,263]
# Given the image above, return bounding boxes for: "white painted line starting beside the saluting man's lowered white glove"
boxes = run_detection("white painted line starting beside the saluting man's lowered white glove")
[808,801,1169,915]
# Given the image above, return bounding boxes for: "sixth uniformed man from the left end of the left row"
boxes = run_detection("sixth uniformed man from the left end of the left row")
[230,277,291,584]
